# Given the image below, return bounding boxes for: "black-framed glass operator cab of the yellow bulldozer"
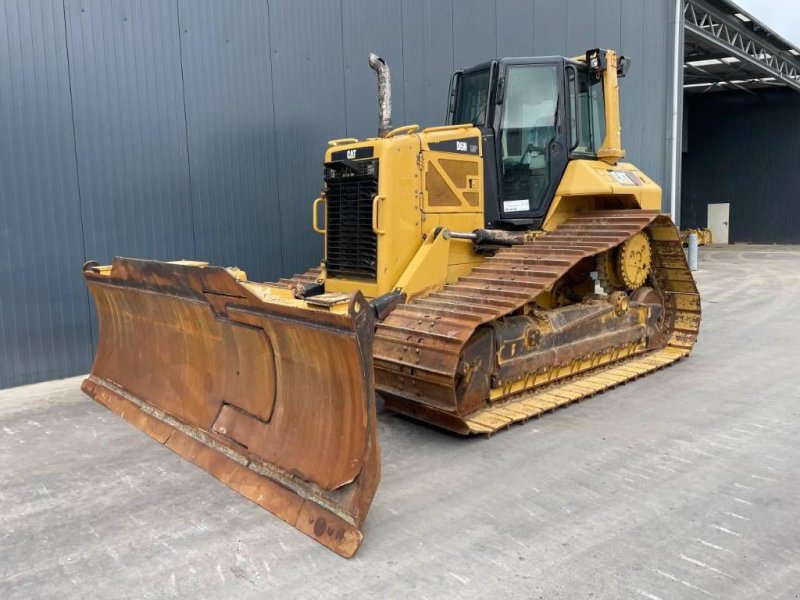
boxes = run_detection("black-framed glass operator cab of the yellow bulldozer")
[447,50,629,229]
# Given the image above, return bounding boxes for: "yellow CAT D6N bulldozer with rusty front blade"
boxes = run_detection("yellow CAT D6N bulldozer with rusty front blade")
[82,49,700,557]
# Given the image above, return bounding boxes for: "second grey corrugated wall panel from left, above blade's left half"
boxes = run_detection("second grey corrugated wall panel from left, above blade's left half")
[65,0,195,262]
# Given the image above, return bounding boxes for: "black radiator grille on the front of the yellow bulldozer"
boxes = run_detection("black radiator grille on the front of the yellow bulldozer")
[325,160,378,280]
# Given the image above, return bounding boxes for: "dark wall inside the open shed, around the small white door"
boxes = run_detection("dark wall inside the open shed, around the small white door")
[682,91,800,244]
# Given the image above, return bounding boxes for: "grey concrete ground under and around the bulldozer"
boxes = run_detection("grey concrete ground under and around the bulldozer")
[0,246,800,600]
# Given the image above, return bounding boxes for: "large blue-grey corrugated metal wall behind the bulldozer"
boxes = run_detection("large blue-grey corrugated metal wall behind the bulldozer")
[0,0,675,388]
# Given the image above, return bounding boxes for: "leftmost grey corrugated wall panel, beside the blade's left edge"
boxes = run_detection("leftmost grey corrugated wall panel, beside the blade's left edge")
[0,0,91,387]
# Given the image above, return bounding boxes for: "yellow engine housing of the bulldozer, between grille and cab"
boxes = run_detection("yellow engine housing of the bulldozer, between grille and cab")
[320,127,484,297]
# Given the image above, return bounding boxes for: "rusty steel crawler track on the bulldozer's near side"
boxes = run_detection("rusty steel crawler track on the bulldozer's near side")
[373,210,700,434]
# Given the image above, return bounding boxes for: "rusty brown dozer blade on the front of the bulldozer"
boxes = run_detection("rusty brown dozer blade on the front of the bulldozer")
[82,258,380,556]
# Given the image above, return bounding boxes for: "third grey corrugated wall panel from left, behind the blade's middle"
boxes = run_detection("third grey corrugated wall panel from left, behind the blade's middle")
[178,0,283,281]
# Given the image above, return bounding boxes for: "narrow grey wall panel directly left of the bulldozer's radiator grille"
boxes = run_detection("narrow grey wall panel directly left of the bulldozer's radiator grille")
[269,0,347,274]
